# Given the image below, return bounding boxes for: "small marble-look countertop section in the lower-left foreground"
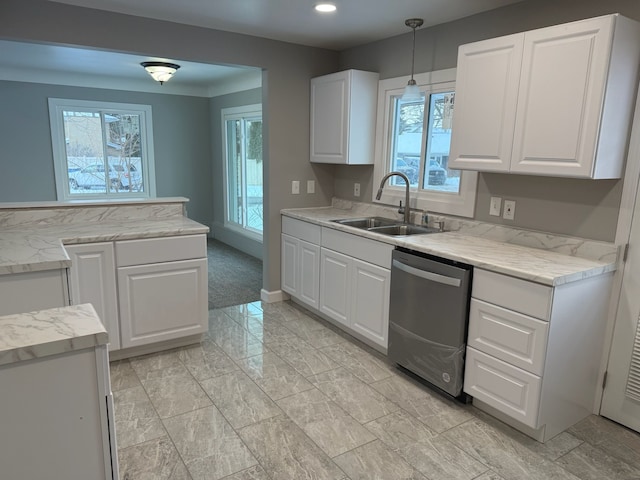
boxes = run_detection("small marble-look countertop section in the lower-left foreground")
[0,303,109,365]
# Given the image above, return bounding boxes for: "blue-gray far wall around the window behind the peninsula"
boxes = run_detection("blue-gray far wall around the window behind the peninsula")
[0,81,213,223]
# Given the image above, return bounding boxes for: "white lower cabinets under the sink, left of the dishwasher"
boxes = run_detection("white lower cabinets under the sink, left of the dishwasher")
[281,217,393,350]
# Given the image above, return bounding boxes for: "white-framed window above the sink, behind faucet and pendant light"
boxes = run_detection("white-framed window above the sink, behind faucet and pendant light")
[373,69,477,217]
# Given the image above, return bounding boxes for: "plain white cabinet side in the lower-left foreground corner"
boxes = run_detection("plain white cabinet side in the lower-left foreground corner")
[0,345,119,480]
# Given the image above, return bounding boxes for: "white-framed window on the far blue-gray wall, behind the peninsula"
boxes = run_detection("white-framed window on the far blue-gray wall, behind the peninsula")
[49,98,155,200]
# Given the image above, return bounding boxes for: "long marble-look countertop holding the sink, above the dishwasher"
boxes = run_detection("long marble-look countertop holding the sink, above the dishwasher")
[281,207,616,286]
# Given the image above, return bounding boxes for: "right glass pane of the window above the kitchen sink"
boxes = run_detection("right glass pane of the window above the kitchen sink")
[422,92,460,193]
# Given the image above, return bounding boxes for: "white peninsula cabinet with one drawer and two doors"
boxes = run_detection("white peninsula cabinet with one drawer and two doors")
[64,235,209,355]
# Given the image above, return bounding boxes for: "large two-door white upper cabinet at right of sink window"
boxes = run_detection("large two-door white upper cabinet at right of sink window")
[450,15,640,179]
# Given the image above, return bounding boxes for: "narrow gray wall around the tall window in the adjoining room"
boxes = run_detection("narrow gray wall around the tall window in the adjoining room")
[209,88,263,258]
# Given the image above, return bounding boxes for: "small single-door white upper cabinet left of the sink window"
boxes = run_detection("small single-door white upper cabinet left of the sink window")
[310,70,378,165]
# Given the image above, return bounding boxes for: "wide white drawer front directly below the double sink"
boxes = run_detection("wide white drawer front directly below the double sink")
[322,227,394,270]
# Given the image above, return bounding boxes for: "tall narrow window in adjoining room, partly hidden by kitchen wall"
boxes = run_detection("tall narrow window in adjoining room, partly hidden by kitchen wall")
[222,105,263,240]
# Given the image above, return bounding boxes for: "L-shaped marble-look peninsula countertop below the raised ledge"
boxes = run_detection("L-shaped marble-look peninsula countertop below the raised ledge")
[0,216,209,275]
